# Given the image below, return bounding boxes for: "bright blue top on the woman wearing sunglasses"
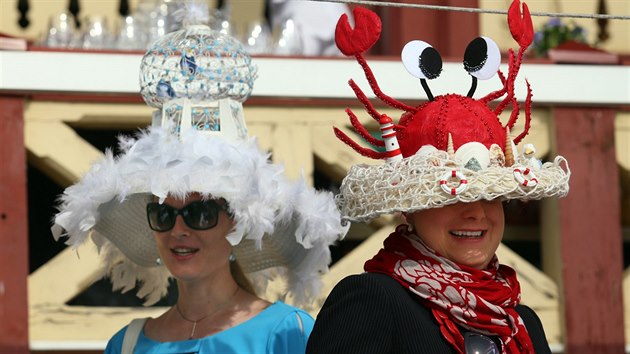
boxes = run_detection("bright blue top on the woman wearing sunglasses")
[105,301,314,354]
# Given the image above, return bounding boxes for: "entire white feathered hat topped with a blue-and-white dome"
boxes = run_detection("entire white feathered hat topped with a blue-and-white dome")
[53,8,347,305]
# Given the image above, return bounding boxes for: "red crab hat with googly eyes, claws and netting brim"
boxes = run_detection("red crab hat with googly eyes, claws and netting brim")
[334,0,571,221]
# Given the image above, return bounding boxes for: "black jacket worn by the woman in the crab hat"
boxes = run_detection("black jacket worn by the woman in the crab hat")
[306,273,551,354]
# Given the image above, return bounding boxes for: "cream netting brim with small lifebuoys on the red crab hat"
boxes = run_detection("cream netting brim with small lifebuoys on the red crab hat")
[337,151,571,221]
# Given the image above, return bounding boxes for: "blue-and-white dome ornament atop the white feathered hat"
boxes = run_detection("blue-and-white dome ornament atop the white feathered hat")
[140,4,256,139]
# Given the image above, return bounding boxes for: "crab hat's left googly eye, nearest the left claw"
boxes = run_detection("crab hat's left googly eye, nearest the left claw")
[400,40,442,80]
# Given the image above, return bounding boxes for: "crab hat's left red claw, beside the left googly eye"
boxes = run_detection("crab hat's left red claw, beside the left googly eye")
[335,6,381,55]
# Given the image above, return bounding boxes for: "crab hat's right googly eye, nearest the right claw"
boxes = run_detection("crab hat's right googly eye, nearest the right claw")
[464,37,501,80]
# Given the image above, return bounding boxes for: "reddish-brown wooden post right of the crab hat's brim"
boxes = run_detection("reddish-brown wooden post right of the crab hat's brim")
[554,107,624,354]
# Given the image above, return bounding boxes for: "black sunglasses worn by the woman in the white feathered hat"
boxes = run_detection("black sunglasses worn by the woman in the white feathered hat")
[147,200,228,232]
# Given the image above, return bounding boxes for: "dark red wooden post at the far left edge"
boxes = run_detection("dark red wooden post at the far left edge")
[0,96,29,354]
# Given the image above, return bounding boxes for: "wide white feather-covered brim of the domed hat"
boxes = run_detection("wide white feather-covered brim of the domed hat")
[53,128,347,303]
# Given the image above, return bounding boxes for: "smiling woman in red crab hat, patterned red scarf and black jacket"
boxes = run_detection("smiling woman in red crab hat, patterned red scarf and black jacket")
[307,0,571,354]
